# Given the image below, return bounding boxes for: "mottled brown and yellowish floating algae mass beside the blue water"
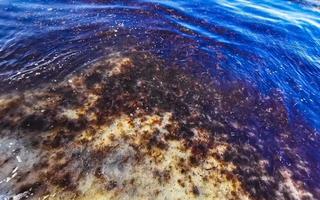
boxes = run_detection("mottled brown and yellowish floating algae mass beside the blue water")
[0,53,320,199]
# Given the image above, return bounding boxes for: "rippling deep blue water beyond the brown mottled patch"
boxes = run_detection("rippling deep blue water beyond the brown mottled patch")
[0,0,320,129]
